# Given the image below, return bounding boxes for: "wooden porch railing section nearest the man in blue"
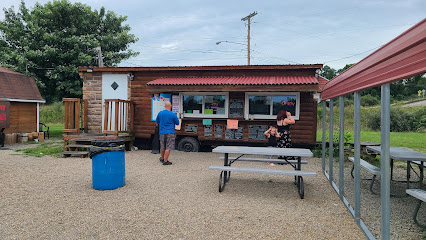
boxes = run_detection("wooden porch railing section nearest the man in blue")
[102,99,134,136]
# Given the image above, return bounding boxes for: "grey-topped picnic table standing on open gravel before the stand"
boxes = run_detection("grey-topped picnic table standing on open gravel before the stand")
[209,146,317,199]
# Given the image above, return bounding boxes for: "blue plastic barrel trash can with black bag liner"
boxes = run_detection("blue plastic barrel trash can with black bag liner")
[91,139,126,190]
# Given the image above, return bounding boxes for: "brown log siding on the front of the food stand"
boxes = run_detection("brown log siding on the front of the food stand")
[131,70,317,145]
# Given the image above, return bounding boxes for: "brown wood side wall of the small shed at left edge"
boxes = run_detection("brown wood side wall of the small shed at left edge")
[4,102,37,133]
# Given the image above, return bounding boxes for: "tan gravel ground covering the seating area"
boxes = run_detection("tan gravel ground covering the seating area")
[0,144,421,239]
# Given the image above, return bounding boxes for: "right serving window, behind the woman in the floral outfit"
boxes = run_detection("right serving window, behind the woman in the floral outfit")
[245,92,300,120]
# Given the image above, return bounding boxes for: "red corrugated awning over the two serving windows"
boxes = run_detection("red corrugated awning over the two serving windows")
[148,76,318,85]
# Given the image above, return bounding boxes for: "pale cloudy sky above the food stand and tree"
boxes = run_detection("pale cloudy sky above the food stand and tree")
[0,0,426,70]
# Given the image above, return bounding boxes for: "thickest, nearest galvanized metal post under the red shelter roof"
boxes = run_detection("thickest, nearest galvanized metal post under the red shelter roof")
[380,83,390,239]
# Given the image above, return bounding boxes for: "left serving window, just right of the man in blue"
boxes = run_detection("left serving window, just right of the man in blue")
[180,92,229,118]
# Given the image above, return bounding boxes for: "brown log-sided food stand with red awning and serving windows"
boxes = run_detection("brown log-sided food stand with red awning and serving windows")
[79,64,326,151]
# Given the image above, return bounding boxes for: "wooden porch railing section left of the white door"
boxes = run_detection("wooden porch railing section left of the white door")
[62,98,88,134]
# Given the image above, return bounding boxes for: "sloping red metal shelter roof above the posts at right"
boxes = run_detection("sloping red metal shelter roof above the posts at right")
[321,18,426,100]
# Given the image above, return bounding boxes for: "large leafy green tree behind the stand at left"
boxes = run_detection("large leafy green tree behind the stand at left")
[0,0,139,102]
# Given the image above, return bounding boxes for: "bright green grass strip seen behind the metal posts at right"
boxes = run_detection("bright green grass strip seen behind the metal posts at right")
[317,130,426,153]
